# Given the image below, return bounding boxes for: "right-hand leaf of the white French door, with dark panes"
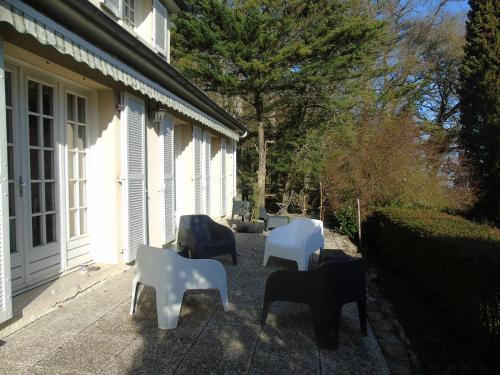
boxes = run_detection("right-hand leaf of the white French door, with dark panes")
[24,79,61,282]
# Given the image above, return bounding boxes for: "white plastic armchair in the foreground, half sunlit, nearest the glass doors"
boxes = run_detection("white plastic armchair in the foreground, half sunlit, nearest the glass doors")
[130,245,229,329]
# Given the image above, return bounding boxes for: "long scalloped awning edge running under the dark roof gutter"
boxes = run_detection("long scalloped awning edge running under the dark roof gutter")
[0,0,239,140]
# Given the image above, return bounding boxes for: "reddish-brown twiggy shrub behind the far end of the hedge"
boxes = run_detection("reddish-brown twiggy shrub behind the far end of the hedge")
[324,114,474,215]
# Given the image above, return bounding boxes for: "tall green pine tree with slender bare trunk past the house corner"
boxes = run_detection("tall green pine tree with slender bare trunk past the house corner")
[172,0,383,206]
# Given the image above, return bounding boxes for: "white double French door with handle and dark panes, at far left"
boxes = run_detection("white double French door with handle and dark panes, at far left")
[5,68,61,291]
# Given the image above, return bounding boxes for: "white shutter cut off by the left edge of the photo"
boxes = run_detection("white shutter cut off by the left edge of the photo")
[0,37,12,323]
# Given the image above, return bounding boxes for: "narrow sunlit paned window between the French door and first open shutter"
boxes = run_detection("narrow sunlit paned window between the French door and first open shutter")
[66,93,88,239]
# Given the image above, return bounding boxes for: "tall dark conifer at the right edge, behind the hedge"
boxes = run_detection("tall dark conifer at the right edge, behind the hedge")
[460,0,500,225]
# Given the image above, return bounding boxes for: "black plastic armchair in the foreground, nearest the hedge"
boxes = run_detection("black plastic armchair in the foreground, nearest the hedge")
[261,258,367,349]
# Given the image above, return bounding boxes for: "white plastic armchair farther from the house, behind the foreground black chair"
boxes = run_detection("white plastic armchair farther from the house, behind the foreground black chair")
[263,219,324,271]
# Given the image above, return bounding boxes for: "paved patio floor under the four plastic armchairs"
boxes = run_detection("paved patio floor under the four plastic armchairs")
[0,232,389,374]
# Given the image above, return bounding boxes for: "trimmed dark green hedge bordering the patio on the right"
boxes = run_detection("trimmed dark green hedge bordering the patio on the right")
[364,208,500,368]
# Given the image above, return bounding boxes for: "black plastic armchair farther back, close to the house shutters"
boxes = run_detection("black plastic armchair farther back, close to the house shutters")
[177,215,236,264]
